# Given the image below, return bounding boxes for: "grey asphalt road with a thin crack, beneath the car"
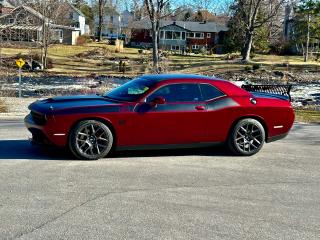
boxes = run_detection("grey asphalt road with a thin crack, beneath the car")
[0,121,320,240]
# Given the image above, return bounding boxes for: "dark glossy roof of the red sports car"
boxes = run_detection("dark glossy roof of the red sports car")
[140,73,225,82]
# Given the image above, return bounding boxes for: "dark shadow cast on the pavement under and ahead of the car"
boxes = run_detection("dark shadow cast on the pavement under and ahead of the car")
[0,140,231,161]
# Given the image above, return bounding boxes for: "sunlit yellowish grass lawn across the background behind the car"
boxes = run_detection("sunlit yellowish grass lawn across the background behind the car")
[2,43,320,76]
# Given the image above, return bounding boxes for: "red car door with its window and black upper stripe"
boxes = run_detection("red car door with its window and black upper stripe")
[134,83,206,145]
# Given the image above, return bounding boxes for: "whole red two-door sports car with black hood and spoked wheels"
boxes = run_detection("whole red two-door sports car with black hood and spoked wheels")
[25,74,294,159]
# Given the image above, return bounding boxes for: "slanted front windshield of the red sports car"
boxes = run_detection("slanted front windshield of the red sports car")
[105,78,156,102]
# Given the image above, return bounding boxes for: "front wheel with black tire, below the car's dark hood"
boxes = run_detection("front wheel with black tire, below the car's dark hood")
[69,120,114,160]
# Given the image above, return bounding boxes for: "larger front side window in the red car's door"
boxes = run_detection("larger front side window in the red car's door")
[147,83,202,103]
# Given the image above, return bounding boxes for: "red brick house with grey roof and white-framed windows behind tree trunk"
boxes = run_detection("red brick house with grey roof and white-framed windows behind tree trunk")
[131,20,228,53]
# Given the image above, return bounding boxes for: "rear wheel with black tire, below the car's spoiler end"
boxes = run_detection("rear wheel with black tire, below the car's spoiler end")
[228,118,266,156]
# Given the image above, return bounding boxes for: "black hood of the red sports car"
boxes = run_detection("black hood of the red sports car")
[29,95,122,114]
